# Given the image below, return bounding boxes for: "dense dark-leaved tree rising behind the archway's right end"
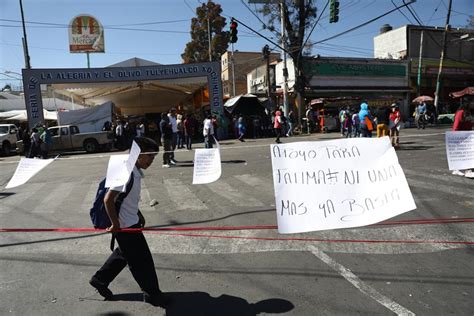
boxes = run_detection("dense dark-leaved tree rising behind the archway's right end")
[181,1,229,64]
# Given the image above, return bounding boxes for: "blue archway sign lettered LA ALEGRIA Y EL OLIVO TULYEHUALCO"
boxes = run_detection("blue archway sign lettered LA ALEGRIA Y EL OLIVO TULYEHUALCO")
[22,62,223,128]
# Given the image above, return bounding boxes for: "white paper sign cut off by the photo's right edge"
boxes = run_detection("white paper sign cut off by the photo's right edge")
[446,131,474,170]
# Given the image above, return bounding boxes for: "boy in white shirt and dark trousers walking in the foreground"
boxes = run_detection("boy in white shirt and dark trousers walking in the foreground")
[89,137,169,307]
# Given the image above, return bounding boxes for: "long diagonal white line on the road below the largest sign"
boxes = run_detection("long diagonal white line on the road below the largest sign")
[309,246,415,315]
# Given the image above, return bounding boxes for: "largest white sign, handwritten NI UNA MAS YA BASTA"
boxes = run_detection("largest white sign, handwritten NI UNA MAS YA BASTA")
[271,137,416,233]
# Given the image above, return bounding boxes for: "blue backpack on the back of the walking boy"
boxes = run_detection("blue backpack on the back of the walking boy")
[89,172,133,229]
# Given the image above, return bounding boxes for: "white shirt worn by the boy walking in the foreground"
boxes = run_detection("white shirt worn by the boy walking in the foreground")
[110,167,142,228]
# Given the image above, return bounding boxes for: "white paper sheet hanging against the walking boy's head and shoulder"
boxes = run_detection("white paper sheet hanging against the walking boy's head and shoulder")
[105,141,141,188]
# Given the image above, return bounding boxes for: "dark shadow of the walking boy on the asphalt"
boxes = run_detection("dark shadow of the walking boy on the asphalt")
[114,292,294,316]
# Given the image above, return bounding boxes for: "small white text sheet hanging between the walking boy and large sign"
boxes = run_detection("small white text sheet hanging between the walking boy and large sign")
[193,140,222,184]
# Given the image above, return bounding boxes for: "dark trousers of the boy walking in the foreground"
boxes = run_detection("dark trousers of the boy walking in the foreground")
[94,233,161,296]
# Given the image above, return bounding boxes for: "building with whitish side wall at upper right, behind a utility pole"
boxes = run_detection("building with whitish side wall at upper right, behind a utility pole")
[374,25,474,113]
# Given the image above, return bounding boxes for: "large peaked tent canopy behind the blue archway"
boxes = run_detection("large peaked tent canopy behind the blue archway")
[52,58,207,115]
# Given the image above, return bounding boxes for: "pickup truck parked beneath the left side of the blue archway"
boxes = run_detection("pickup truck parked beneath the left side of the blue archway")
[48,125,114,153]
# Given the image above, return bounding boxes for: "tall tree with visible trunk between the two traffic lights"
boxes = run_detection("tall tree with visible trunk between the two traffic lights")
[259,0,317,109]
